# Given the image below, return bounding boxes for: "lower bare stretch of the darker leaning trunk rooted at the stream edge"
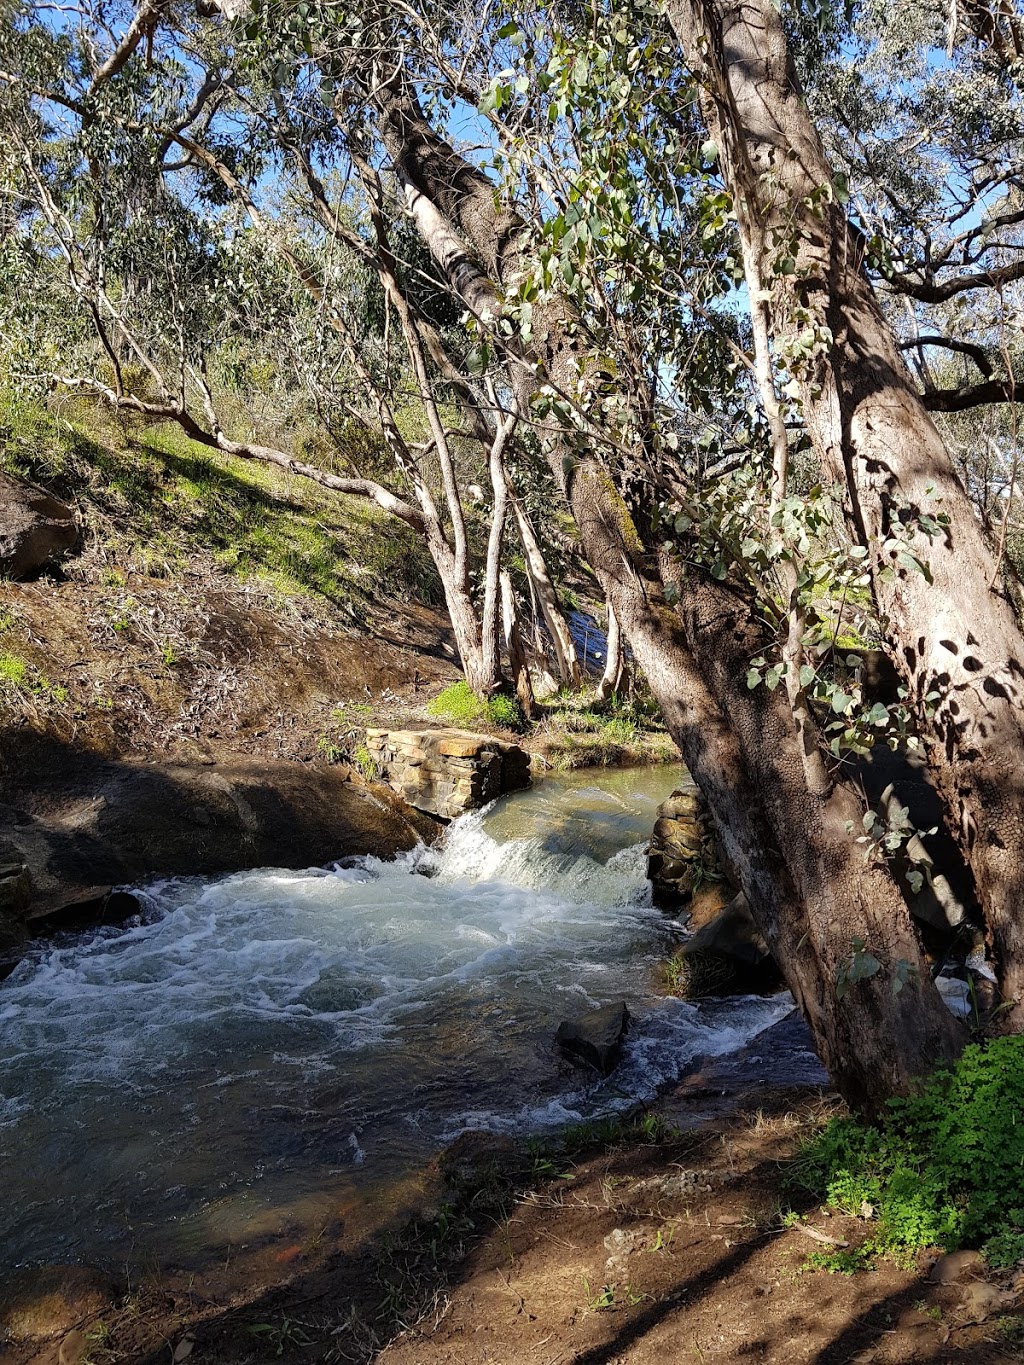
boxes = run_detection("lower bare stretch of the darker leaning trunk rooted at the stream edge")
[567,463,964,1111]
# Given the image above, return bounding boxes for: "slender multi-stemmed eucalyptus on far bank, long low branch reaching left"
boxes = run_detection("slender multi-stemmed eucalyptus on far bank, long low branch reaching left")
[0,2,562,695]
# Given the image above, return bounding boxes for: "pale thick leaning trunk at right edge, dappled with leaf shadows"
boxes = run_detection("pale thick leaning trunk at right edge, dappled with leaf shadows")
[666,0,1024,1029]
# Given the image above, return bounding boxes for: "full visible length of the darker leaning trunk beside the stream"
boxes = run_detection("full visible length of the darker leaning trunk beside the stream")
[373,66,961,1108]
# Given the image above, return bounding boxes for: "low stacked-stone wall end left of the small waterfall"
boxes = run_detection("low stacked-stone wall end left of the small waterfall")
[366,730,530,820]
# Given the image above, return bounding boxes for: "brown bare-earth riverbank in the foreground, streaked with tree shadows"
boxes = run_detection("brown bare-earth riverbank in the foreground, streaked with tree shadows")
[4,1066,1024,1365]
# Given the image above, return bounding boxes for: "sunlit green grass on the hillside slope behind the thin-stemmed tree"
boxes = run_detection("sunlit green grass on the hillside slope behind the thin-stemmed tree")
[0,392,441,606]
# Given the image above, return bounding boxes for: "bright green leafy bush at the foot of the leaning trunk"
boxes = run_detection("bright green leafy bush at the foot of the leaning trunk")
[793,1036,1024,1267]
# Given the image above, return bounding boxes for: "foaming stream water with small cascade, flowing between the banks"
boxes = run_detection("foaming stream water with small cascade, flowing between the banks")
[0,768,789,1265]
